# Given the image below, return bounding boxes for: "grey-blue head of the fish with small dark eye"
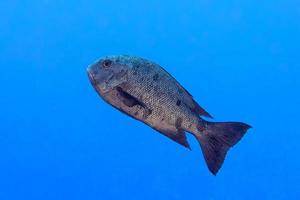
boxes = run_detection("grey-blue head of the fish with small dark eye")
[87,56,132,94]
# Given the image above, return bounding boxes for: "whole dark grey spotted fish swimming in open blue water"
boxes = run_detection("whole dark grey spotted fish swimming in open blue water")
[87,55,252,175]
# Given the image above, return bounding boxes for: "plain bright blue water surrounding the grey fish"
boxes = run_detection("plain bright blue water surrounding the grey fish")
[0,0,300,200]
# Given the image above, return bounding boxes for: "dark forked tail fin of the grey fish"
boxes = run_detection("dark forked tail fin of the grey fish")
[196,122,251,175]
